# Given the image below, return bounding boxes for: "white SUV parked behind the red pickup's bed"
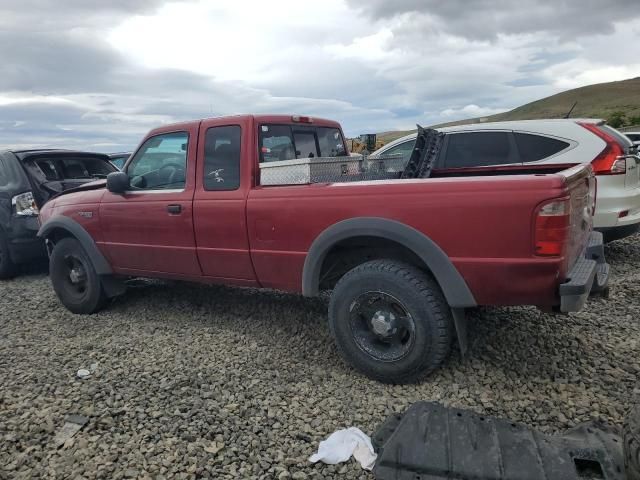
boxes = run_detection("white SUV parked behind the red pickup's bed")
[371,119,640,241]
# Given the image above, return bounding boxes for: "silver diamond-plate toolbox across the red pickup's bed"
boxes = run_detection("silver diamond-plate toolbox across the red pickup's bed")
[260,154,408,185]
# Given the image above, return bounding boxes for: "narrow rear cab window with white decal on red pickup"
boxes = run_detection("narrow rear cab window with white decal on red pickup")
[203,125,241,190]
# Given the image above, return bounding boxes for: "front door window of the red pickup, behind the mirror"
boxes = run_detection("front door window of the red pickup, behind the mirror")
[127,132,189,190]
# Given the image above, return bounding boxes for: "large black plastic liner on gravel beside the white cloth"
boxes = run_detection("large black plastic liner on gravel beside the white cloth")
[373,402,625,480]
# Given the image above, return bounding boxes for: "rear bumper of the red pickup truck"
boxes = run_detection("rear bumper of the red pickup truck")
[559,232,609,313]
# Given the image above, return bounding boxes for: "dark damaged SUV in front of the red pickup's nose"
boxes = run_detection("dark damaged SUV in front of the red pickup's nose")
[0,150,117,278]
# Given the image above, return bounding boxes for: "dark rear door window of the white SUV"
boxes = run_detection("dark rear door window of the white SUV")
[444,132,517,168]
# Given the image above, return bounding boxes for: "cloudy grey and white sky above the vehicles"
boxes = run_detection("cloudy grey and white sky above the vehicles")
[0,0,640,152]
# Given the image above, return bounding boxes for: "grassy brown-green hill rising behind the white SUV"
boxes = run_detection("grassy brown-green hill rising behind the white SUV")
[378,77,640,143]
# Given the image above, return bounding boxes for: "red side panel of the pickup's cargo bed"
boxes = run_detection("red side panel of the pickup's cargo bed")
[247,175,566,305]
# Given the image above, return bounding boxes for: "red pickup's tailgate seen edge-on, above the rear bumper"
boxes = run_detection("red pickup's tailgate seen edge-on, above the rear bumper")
[559,165,596,268]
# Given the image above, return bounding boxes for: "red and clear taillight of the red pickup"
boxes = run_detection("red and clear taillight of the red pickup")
[535,198,571,257]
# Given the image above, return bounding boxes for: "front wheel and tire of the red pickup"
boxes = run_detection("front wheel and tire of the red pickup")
[49,238,106,314]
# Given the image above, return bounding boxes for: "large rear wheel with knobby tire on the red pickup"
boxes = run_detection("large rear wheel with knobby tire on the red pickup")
[329,260,453,384]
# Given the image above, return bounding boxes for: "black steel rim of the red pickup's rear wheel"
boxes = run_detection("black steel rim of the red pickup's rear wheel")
[349,291,416,362]
